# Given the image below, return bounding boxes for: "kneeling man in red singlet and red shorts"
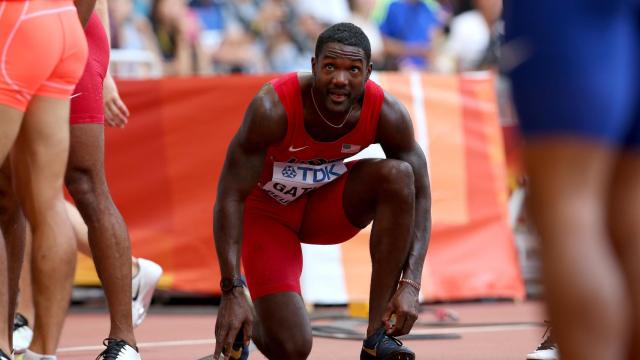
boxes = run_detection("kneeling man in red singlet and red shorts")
[214,23,431,360]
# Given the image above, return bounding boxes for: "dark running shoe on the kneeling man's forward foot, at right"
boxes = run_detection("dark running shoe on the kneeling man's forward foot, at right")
[360,327,416,360]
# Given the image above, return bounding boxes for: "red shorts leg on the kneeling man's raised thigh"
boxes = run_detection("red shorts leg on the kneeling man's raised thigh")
[300,166,364,245]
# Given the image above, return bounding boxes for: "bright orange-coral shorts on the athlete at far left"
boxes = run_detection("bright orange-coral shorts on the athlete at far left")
[0,0,87,112]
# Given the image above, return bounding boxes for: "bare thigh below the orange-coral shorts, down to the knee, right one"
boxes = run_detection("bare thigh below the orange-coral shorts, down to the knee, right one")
[11,96,69,214]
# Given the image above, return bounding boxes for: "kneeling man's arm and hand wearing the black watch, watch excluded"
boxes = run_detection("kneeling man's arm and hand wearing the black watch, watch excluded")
[213,85,287,359]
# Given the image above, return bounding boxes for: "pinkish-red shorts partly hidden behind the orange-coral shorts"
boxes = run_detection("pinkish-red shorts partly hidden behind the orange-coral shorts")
[69,13,109,125]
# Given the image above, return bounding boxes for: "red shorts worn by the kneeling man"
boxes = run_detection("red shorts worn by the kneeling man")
[242,172,361,299]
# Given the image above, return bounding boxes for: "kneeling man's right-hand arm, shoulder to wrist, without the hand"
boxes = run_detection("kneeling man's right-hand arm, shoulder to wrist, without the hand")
[377,93,431,294]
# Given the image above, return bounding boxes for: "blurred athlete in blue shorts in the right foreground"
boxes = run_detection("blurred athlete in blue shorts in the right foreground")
[503,0,640,360]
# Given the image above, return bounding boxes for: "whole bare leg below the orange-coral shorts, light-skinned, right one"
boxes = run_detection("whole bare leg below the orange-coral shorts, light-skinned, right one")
[12,96,76,354]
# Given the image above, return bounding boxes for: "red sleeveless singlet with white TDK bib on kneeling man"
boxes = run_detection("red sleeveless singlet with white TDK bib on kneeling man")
[258,73,384,204]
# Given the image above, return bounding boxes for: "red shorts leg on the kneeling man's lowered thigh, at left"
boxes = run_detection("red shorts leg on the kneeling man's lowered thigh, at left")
[242,204,302,299]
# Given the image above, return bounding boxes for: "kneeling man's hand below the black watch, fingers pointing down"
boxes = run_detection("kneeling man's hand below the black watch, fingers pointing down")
[213,288,253,359]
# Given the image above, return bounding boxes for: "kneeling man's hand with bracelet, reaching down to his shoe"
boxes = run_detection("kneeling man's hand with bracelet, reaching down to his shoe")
[382,284,420,336]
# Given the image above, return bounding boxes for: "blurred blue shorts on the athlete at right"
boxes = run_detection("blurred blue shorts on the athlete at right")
[503,0,638,146]
